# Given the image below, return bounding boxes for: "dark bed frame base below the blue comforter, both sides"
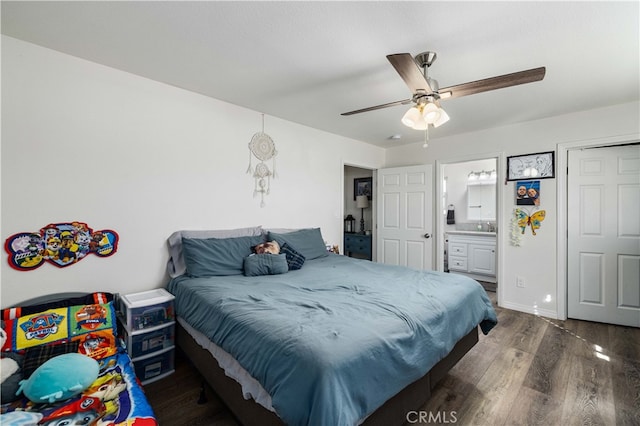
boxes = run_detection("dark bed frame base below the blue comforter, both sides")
[176,322,478,426]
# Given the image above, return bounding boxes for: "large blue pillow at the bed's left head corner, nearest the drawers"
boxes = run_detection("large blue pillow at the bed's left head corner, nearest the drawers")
[182,235,264,278]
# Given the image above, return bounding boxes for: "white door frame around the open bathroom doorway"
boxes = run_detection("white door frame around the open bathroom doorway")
[434,152,504,306]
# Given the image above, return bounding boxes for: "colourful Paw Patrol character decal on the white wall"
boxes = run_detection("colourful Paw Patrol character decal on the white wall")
[4,222,118,271]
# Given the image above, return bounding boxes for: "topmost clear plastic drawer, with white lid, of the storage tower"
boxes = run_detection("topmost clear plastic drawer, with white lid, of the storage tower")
[119,288,175,332]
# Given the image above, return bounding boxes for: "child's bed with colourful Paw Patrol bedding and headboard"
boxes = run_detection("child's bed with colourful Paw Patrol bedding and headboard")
[0,293,157,426]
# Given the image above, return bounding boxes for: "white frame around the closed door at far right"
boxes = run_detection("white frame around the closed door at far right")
[556,133,640,321]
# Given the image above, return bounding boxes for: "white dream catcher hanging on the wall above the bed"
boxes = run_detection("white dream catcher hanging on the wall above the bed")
[247,114,278,207]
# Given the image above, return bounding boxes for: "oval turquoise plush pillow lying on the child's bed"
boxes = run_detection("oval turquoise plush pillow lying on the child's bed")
[17,354,100,404]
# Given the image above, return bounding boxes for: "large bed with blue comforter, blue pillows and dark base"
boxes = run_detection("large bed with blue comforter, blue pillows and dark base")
[167,227,497,426]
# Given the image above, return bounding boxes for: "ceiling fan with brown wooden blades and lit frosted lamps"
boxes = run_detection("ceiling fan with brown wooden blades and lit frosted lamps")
[341,52,546,130]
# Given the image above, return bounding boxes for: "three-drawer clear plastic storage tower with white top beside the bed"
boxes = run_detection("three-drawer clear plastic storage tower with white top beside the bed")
[118,288,176,385]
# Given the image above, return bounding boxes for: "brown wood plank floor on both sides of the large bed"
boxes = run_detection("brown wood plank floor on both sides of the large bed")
[145,292,640,426]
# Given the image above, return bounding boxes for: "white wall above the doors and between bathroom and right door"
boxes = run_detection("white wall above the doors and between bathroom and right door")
[385,102,640,317]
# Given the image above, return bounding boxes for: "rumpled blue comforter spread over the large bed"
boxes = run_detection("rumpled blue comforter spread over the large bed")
[168,255,496,426]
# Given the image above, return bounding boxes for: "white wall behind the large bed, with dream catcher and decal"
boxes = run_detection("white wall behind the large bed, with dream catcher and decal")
[0,36,384,306]
